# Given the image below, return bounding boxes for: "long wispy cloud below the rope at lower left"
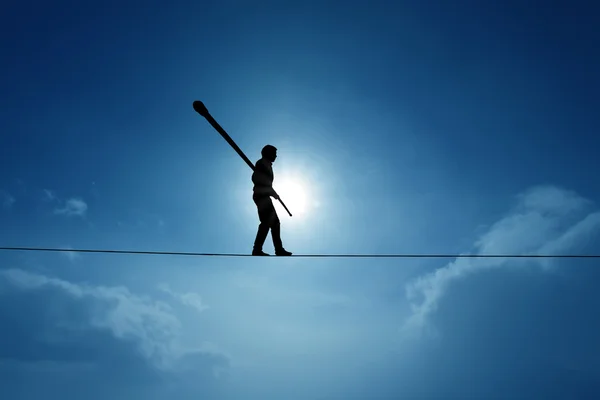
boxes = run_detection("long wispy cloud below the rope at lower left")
[0,269,223,370]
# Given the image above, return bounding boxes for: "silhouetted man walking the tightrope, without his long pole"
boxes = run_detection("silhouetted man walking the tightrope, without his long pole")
[252,144,292,256]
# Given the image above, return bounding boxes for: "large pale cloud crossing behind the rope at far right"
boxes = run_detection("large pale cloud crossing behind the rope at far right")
[404,186,600,332]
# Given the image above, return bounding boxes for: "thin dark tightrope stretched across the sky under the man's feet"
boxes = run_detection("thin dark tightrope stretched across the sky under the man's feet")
[0,247,600,258]
